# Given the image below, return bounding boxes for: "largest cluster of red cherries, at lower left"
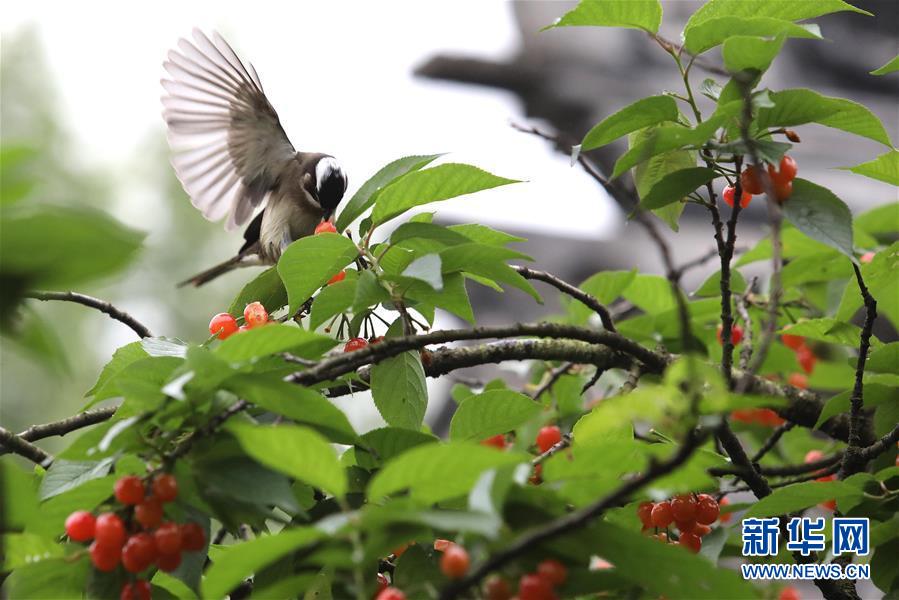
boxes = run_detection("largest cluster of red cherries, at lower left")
[65,473,206,600]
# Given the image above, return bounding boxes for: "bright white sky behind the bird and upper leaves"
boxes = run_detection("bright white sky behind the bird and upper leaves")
[2,0,619,239]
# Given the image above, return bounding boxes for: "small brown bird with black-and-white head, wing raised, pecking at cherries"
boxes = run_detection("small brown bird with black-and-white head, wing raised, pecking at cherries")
[161,29,347,287]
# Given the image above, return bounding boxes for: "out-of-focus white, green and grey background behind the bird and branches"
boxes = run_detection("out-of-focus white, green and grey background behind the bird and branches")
[0,0,899,451]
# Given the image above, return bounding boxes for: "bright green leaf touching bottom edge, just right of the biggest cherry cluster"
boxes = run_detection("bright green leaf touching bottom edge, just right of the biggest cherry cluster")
[202,527,325,600]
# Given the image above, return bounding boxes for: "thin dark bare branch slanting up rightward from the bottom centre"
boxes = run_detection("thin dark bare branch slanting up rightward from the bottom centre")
[440,431,706,600]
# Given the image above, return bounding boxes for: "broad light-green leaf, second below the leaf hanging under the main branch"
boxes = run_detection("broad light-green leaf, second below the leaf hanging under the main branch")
[367,441,528,504]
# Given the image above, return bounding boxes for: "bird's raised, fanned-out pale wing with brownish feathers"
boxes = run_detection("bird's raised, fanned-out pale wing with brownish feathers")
[162,29,296,229]
